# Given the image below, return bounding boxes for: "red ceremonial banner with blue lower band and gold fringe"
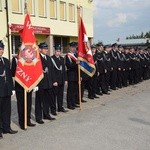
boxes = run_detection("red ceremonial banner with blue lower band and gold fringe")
[78,18,96,77]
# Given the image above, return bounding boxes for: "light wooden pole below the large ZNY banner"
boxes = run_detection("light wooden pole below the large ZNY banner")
[24,89,27,130]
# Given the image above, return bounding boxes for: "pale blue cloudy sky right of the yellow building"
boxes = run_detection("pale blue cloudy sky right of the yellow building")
[93,0,150,44]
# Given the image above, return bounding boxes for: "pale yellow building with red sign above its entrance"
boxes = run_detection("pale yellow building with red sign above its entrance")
[0,0,93,58]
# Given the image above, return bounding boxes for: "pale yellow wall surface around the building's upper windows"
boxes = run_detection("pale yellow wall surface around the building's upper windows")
[0,0,93,56]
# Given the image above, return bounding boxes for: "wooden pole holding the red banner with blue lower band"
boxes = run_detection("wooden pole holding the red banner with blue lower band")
[77,5,82,110]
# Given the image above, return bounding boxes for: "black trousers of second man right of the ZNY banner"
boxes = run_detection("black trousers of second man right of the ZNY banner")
[53,84,64,112]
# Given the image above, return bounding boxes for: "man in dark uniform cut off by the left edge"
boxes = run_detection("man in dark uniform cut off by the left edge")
[0,41,18,139]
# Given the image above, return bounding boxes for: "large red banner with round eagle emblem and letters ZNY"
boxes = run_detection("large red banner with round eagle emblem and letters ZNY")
[15,14,43,92]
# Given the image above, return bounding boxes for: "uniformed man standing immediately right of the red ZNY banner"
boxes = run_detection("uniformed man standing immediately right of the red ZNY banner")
[35,42,55,124]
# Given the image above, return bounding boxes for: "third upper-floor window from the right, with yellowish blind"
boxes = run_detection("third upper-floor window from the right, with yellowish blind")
[49,0,57,19]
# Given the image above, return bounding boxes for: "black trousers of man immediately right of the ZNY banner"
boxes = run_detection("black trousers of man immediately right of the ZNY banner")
[35,88,55,120]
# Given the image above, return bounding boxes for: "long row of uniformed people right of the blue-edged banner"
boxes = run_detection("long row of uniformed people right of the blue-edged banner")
[87,43,150,99]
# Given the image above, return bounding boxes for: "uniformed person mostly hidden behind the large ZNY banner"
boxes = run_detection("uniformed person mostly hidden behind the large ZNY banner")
[11,43,36,130]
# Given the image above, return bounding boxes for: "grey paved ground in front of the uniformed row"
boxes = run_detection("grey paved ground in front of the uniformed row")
[0,81,150,150]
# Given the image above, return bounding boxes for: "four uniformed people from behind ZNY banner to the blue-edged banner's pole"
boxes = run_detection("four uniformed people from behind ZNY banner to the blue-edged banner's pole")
[11,42,86,130]
